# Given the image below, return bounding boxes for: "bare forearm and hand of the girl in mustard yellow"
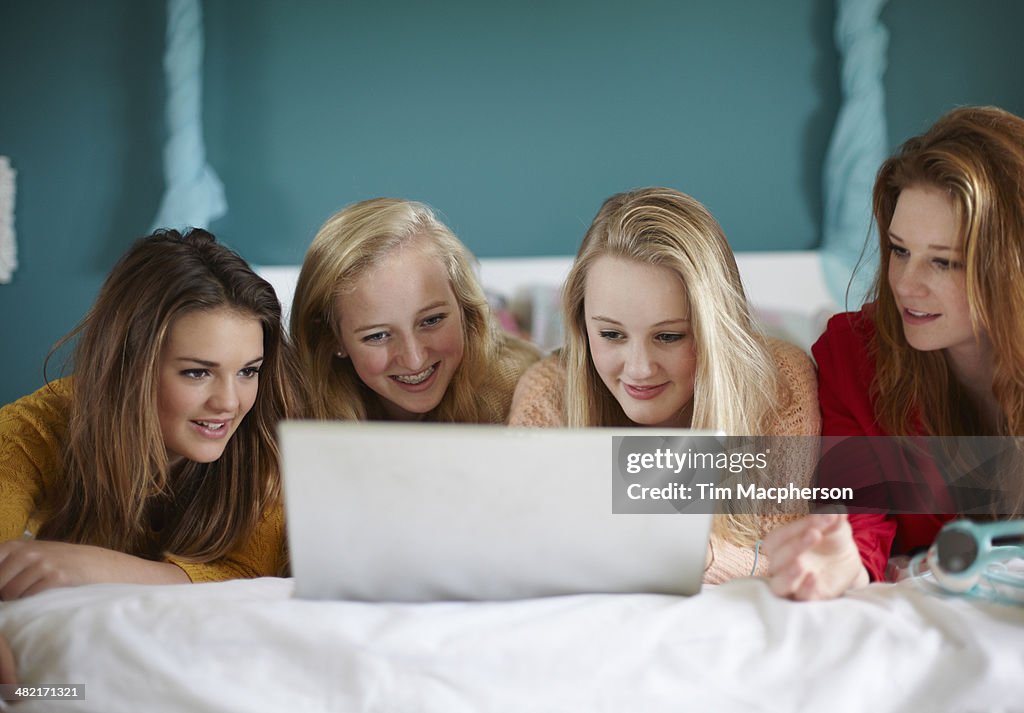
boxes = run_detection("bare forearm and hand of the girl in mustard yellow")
[0,540,188,601]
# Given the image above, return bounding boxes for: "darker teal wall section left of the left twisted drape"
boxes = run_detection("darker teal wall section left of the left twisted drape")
[0,0,164,403]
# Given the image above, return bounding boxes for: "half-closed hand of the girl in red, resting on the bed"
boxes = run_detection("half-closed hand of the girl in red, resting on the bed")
[762,513,870,600]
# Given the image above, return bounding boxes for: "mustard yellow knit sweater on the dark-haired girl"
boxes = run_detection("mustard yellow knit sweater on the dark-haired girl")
[0,379,284,582]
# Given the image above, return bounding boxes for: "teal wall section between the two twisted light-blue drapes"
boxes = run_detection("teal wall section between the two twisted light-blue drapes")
[197,0,839,262]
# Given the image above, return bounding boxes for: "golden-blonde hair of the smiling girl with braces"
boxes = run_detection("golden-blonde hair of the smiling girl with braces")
[291,198,536,423]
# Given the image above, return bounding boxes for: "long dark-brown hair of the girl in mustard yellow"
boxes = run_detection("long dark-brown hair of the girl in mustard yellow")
[39,229,295,562]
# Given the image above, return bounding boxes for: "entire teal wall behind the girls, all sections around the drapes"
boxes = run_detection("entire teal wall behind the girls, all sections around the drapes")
[0,0,1024,403]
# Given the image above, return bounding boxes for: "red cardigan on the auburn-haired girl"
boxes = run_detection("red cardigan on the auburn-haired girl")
[811,305,952,581]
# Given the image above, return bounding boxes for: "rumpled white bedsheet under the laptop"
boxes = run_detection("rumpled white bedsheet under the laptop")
[0,579,1024,713]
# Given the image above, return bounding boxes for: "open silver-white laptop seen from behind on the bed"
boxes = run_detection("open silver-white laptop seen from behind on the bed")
[280,421,712,601]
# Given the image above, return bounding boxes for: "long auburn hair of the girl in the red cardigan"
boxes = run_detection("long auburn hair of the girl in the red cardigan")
[872,107,1024,435]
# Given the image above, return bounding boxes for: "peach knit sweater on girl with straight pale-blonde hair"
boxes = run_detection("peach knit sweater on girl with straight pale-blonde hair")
[509,339,821,584]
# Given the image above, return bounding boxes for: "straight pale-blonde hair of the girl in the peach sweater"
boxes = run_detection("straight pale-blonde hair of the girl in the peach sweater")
[562,187,780,545]
